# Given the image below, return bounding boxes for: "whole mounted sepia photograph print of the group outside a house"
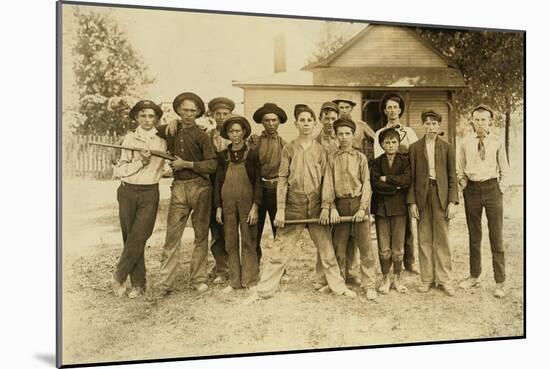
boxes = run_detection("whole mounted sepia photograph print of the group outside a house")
[56,1,526,366]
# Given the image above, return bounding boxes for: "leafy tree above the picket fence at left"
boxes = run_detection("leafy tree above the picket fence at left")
[73,8,153,134]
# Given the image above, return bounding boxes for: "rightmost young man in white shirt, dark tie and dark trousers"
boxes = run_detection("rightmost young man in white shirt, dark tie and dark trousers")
[458,105,508,298]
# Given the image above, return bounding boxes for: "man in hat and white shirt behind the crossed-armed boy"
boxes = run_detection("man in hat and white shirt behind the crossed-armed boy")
[374,92,419,274]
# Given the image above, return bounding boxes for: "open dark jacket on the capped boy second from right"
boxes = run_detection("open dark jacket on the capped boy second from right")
[407,137,458,210]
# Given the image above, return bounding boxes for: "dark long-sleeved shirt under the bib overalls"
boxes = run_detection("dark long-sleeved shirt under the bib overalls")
[213,144,262,209]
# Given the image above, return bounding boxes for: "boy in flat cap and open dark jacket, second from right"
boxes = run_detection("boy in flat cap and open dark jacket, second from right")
[407,110,458,296]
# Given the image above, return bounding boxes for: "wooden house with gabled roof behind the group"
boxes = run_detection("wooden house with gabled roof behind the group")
[233,24,464,144]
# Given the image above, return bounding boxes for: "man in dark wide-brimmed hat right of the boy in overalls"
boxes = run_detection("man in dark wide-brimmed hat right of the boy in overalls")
[249,103,287,261]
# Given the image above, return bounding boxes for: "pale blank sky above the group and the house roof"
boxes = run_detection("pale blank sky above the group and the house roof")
[64,5,366,113]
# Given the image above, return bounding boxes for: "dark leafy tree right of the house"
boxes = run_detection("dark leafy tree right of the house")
[416,28,525,160]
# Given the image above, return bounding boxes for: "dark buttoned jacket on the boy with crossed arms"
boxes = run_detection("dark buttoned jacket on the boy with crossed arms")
[370,153,411,217]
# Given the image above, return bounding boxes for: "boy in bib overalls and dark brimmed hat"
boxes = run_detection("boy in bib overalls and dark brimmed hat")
[214,114,262,293]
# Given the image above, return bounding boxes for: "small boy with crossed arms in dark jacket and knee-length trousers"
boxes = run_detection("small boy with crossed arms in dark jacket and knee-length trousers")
[371,128,411,294]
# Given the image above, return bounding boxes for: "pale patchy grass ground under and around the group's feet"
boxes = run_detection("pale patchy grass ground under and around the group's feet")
[63,180,524,364]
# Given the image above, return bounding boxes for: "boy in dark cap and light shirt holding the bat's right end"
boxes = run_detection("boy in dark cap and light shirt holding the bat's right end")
[323,117,377,300]
